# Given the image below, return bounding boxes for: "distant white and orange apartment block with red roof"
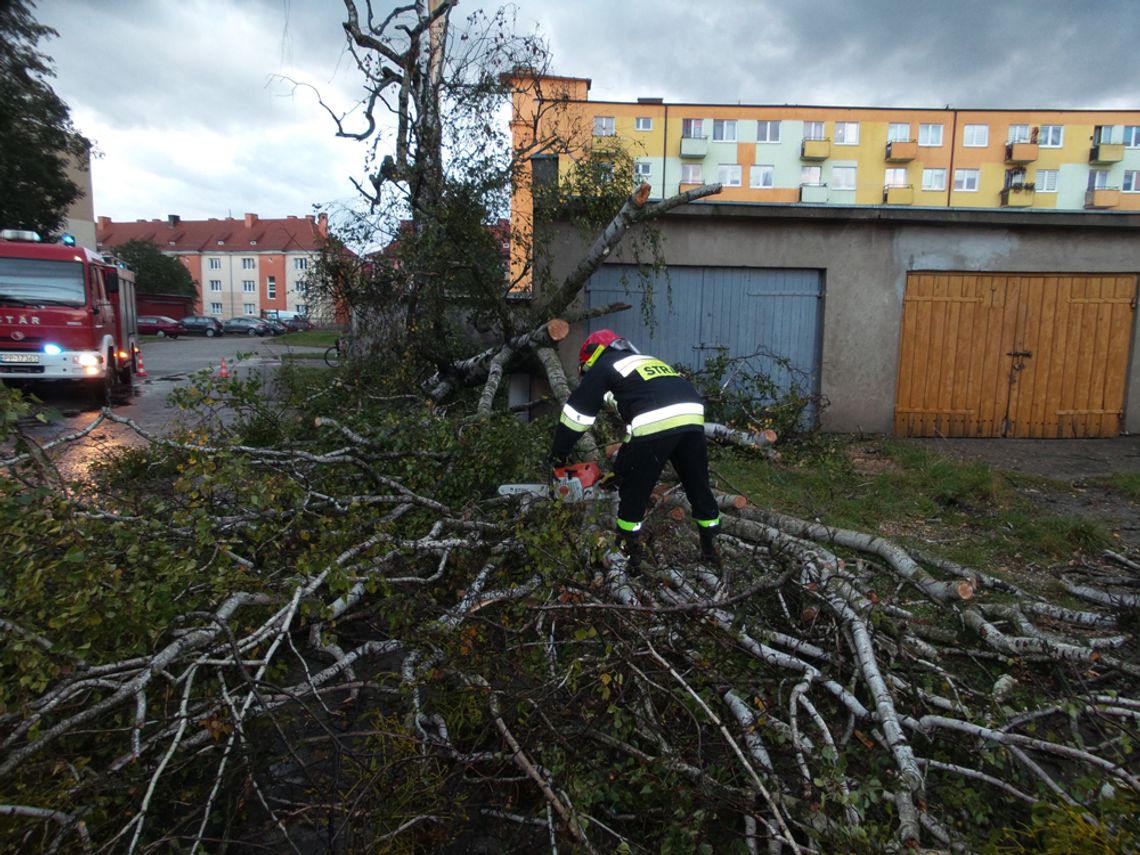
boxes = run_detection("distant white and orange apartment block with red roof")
[96,213,328,318]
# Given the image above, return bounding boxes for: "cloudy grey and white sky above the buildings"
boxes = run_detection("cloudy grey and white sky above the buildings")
[34,0,1140,220]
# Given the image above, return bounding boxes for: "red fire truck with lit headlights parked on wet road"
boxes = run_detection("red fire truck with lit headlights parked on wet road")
[0,229,140,405]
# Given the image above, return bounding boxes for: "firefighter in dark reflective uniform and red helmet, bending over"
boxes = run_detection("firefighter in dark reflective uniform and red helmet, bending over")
[551,329,720,572]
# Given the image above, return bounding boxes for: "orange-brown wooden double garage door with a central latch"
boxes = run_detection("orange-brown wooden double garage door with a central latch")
[895,272,1137,438]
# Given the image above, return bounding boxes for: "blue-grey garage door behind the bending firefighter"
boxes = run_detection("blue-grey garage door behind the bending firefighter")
[586,264,823,424]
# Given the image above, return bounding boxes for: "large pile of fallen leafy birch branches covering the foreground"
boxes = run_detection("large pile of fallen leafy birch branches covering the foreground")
[0,369,1140,853]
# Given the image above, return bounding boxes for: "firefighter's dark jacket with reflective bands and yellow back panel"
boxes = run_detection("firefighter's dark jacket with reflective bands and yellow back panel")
[552,349,705,461]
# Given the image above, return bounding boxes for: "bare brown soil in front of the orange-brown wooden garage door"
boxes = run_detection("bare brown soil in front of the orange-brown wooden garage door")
[905,435,1140,553]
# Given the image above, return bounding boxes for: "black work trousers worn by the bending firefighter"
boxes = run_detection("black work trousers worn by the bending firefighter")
[613,431,720,531]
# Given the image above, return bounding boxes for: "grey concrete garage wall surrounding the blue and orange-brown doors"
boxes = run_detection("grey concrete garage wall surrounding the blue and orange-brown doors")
[545,204,1140,433]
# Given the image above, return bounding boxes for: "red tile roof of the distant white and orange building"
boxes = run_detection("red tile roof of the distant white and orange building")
[95,213,328,253]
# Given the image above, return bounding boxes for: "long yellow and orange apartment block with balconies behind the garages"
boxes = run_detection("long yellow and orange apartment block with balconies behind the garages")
[511,73,1140,211]
